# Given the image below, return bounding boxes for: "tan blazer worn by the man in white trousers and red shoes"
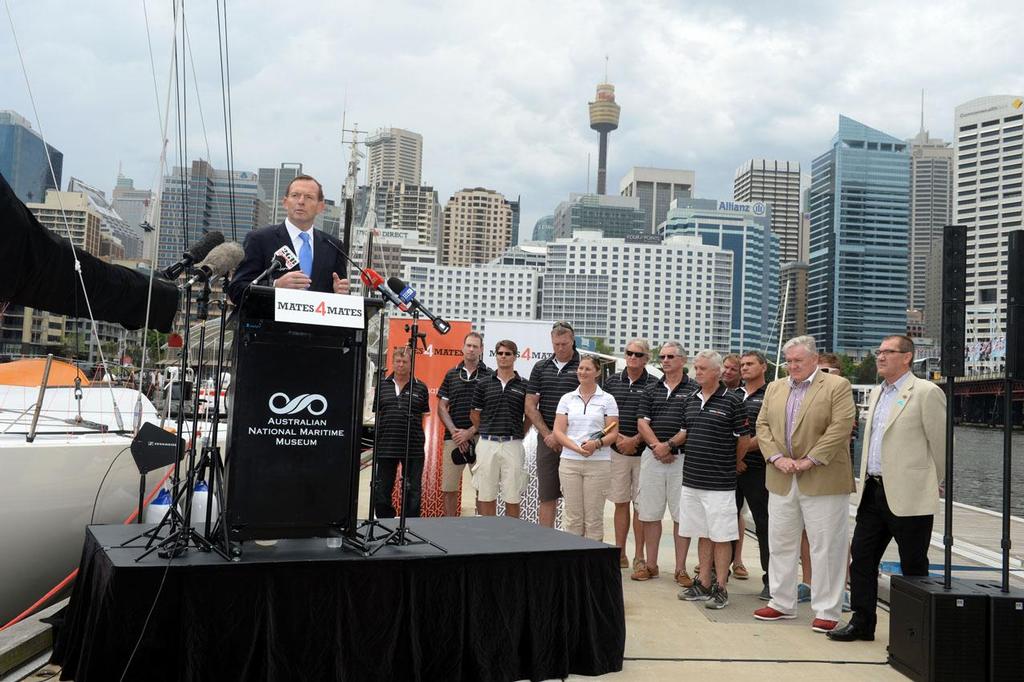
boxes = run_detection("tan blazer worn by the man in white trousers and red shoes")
[758,372,856,496]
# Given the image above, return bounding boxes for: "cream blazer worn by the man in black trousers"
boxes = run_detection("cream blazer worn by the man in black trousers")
[858,375,946,516]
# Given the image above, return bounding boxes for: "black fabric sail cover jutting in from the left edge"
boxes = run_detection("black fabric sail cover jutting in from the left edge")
[0,175,178,333]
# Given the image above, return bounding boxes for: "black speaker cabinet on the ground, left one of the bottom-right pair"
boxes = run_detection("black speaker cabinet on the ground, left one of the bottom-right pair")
[889,576,989,682]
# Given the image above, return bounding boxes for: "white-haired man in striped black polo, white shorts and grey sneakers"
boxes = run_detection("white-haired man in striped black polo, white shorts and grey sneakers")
[679,350,750,608]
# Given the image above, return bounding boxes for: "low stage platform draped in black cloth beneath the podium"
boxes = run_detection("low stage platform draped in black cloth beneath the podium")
[53,517,626,682]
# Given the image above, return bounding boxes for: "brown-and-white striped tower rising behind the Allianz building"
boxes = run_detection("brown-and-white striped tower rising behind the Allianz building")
[732,159,801,263]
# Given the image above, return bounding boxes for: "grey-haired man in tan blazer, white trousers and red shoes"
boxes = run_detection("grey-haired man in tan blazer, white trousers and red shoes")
[754,336,855,632]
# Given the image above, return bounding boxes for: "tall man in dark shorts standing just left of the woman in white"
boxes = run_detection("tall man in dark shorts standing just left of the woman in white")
[526,322,580,528]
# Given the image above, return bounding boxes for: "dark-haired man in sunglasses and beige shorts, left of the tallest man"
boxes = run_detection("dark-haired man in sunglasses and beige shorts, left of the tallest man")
[469,339,526,517]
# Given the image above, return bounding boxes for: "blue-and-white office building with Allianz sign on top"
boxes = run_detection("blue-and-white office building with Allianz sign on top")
[663,199,779,352]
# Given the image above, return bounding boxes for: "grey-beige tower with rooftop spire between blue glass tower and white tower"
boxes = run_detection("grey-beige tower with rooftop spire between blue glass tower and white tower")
[907,129,953,315]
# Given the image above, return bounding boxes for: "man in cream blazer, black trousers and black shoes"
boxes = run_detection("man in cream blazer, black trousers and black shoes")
[828,335,946,642]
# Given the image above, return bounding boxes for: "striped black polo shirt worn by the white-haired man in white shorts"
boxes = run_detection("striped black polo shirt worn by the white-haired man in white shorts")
[683,384,746,491]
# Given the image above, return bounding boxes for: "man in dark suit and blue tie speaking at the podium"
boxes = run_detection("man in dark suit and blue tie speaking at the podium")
[227,175,348,304]
